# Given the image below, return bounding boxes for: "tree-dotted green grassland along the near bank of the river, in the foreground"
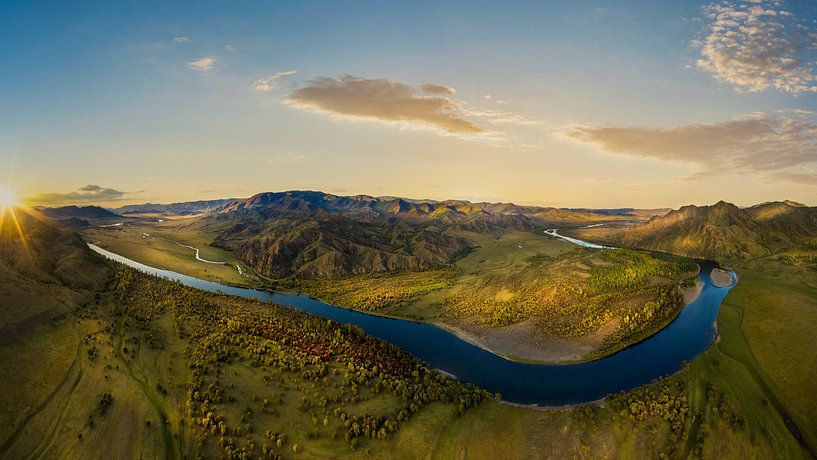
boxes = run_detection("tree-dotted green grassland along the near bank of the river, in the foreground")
[0,255,815,459]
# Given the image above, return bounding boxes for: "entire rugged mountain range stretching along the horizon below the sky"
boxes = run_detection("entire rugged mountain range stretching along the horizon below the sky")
[70,191,817,279]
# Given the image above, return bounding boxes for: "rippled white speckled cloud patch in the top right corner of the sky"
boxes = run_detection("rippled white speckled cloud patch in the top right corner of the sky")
[697,1,817,94]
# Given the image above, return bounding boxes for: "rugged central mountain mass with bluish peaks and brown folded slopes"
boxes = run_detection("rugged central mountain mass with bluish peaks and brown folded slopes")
[201,191,627,278]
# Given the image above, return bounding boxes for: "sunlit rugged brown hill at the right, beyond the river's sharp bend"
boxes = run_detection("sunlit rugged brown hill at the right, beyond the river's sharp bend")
[573,201,817,260]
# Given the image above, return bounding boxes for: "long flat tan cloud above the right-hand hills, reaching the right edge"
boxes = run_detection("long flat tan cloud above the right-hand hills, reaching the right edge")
[566,111,817,182]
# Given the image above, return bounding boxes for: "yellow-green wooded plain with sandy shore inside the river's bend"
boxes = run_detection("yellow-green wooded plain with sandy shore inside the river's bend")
[294,232,697,361]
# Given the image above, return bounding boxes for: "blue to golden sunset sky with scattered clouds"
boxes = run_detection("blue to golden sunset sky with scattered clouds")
[0,0,817,208]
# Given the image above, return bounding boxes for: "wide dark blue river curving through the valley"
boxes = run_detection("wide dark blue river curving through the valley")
[88,237,736,406]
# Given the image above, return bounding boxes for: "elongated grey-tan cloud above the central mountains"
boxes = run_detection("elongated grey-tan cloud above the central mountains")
[284,75,488,135]
